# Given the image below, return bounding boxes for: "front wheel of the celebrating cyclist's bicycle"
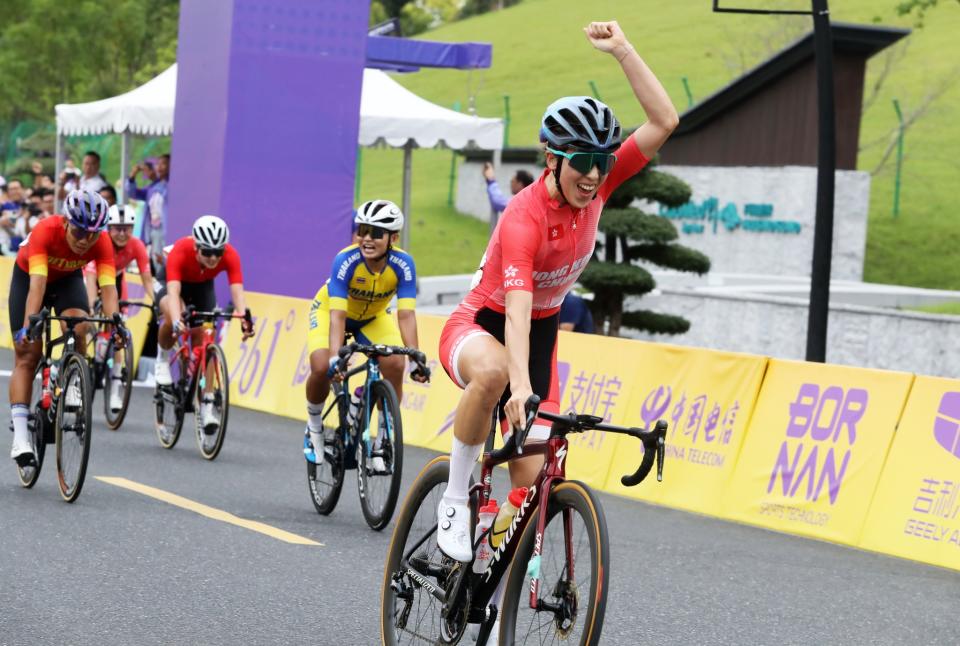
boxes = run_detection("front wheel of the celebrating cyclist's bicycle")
[500,480,610,646]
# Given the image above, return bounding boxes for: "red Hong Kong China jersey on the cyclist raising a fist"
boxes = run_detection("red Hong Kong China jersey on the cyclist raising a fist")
[454,137,649,319]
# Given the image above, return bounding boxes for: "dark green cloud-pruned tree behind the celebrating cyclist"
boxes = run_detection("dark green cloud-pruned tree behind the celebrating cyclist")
[580,163,710,336]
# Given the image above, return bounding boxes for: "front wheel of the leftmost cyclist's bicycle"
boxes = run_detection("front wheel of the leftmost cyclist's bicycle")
[55,352,93,502]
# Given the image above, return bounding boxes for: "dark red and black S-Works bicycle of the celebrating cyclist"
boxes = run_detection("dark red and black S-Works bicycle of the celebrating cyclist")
[381,395,667,646]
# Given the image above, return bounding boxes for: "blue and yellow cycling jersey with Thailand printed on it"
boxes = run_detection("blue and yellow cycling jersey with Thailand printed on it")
[327,244,417,320]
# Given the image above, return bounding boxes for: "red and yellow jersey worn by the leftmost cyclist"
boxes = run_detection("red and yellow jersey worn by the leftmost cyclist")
[17,215,116,287]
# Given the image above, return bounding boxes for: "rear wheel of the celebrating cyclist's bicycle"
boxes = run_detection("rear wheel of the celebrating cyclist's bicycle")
[380,456,469,646]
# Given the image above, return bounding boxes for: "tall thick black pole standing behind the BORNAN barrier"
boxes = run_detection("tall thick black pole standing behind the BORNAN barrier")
[807,0,837,363]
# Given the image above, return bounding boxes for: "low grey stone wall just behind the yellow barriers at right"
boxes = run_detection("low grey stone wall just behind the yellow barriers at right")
[625,289,960,378]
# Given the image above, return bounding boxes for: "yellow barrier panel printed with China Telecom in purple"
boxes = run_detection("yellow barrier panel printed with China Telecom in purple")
[601,343,767,515]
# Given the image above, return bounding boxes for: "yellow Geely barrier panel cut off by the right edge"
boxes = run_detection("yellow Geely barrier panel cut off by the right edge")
[860,377,960,570]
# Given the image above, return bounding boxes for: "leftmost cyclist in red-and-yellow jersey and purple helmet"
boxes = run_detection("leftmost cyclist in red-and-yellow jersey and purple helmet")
[8,191,123,467]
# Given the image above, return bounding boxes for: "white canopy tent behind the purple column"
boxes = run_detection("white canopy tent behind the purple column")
[56,65,503,244]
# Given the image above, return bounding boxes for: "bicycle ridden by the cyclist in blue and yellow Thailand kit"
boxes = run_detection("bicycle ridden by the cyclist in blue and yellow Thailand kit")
[304,343,430,530]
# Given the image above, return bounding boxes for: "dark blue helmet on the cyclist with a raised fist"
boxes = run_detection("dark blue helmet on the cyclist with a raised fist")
[540,96,620,152]
